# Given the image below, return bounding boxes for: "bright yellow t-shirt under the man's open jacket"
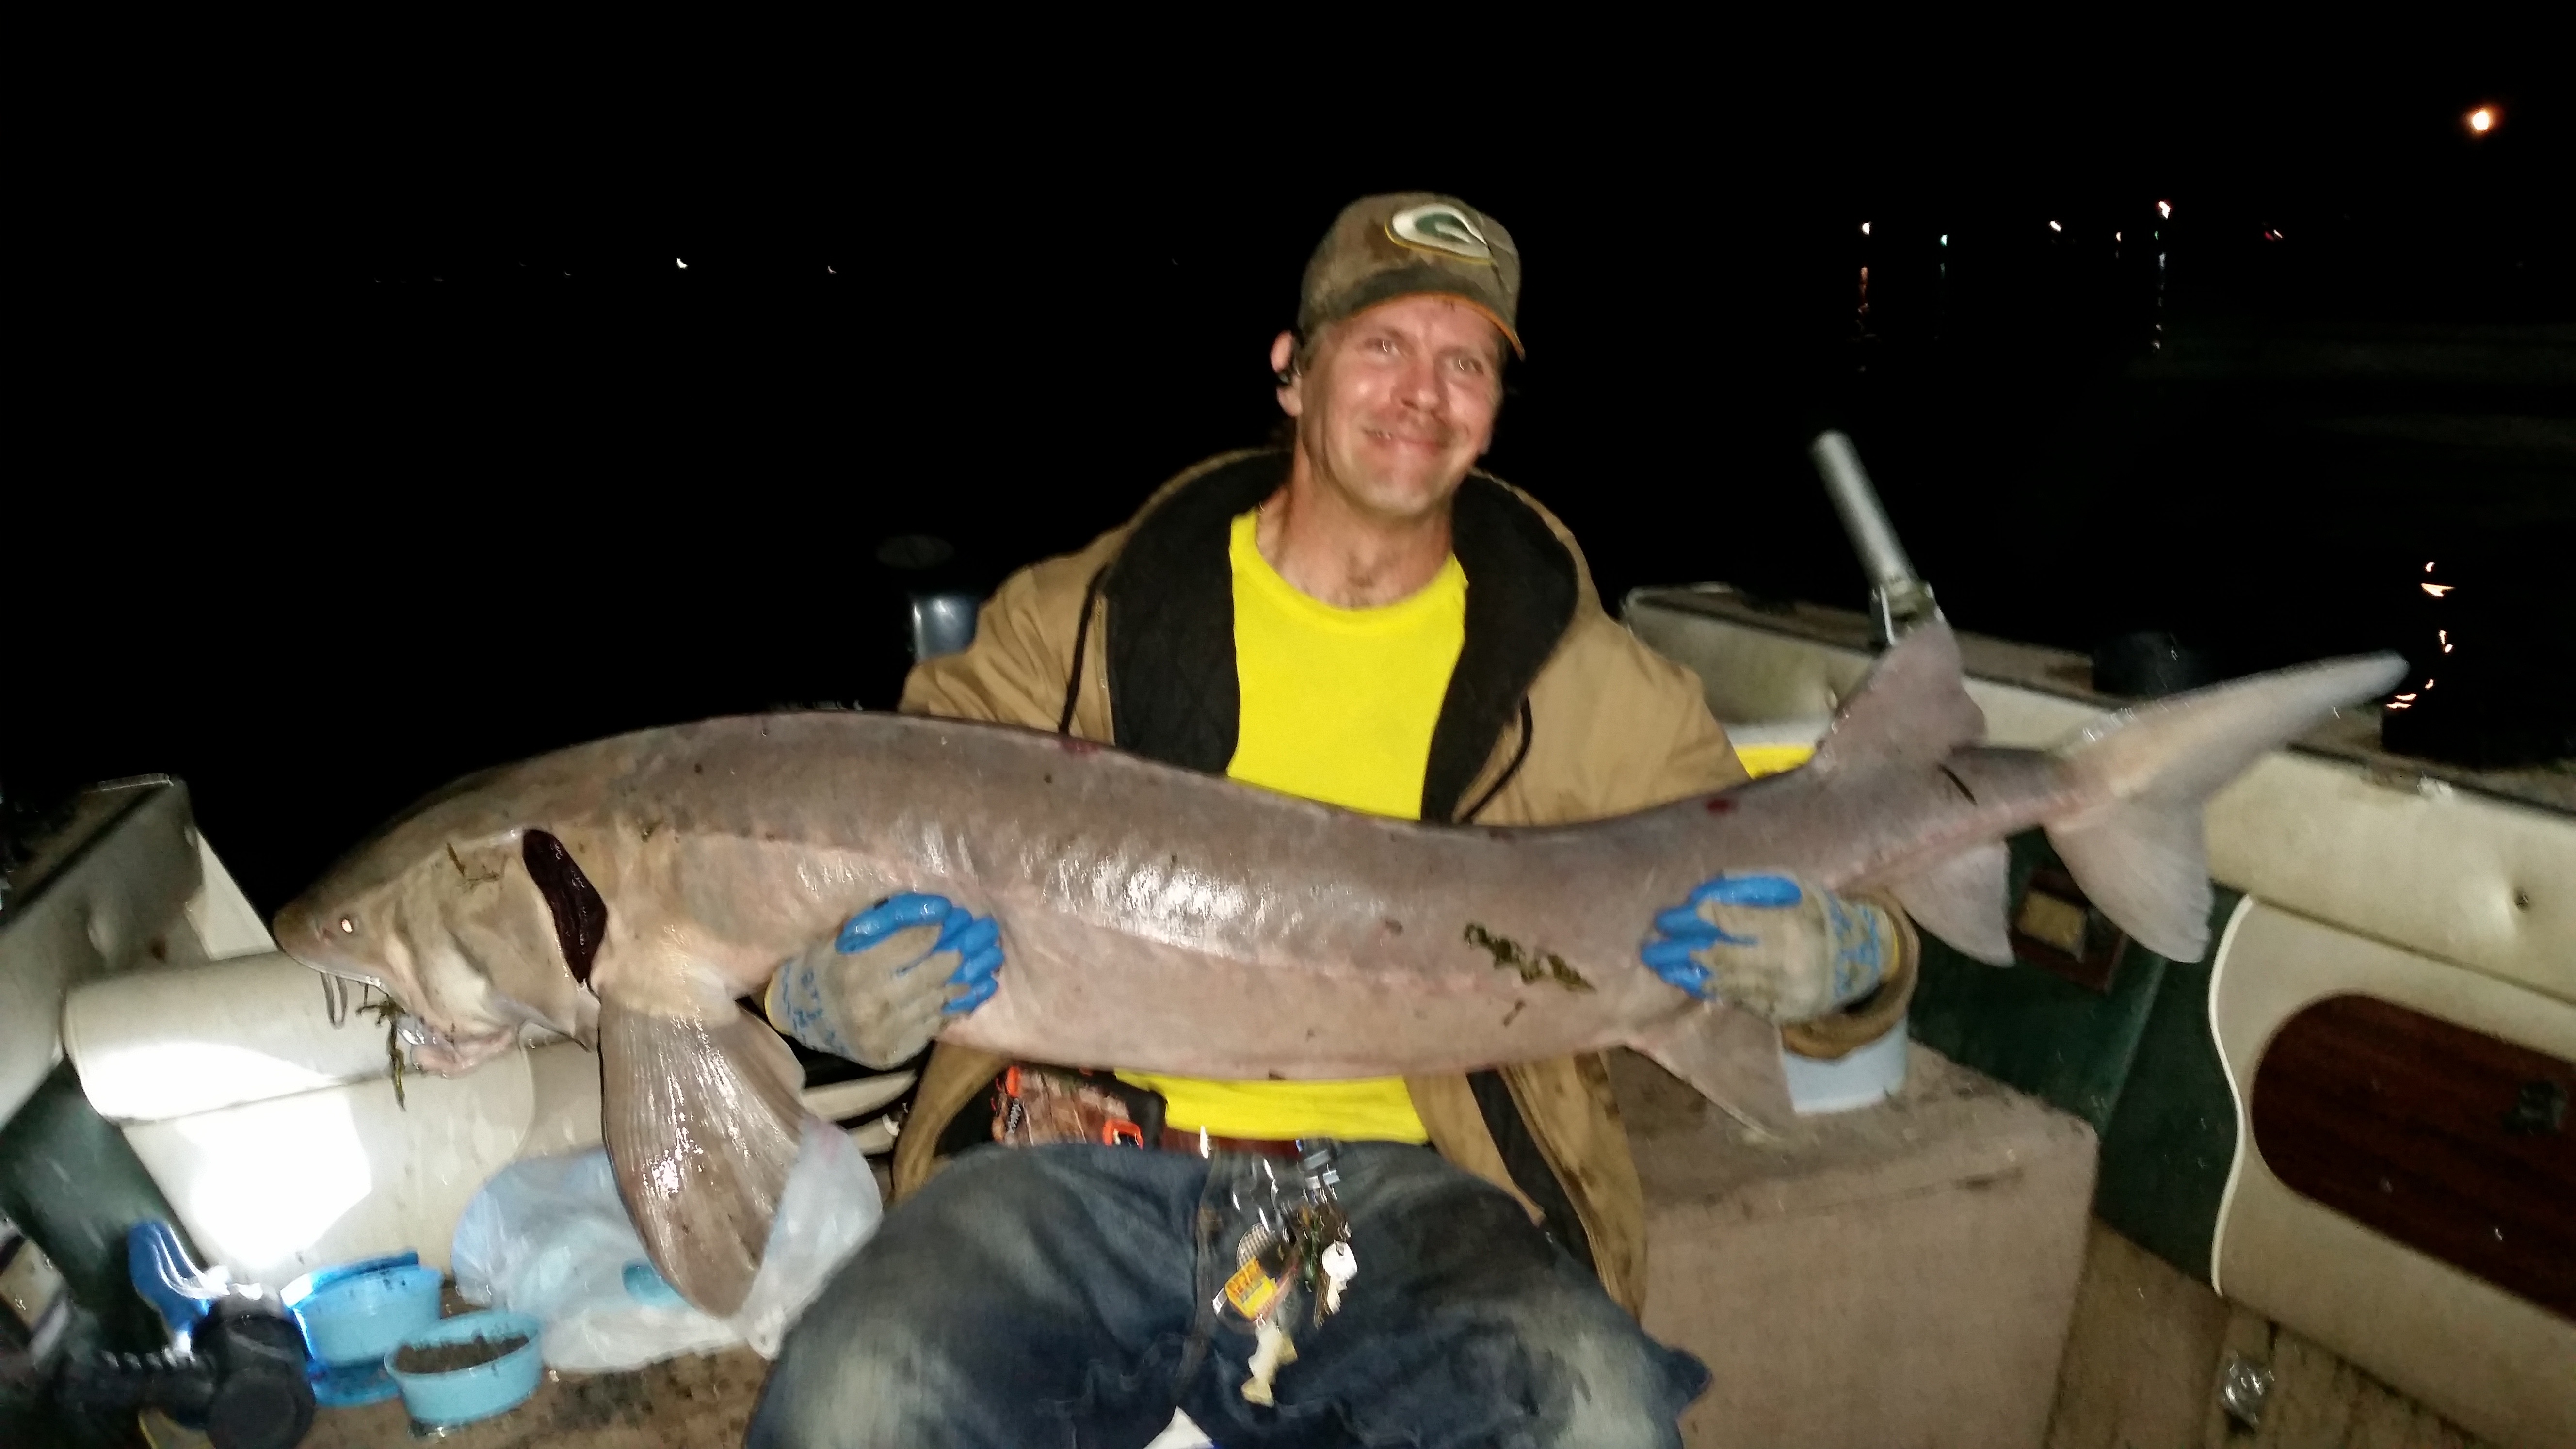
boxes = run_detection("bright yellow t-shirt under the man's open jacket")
[1118,513,1466,1142]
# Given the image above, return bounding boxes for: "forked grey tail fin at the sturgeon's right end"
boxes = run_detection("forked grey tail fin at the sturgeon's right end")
[2048,655,2406,962]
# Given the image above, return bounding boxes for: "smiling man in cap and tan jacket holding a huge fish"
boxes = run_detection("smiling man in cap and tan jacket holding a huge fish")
[752,193,1906,1449]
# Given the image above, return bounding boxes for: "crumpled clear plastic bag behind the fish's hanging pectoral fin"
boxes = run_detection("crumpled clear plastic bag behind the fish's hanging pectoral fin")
[451,1116,884,1371]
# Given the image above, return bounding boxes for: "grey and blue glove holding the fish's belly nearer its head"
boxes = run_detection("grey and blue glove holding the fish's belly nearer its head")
[762,892,1002,1067]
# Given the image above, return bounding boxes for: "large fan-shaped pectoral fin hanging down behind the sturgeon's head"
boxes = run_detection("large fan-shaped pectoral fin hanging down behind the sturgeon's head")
[600,995,804,1318]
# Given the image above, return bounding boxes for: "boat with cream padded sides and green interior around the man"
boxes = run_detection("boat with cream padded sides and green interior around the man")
[0,438,2576,1449]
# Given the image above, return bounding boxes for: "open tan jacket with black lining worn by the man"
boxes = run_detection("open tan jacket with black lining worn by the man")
[894,454,1744,1312]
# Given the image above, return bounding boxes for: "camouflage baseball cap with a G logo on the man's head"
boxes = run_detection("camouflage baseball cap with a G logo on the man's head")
[1296,191,1528,356]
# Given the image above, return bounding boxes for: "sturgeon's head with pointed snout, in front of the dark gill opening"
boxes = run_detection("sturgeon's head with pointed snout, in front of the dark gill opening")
[273,768,597,1073]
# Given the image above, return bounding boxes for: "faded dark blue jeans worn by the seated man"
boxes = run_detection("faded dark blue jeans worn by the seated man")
[747,1142,1708,1449]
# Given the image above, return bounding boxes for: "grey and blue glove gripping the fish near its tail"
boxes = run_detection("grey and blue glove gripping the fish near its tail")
[1638,871,1901,1021]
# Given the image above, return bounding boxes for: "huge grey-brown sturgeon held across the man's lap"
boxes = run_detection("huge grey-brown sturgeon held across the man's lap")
[275,624,2403,1312]
